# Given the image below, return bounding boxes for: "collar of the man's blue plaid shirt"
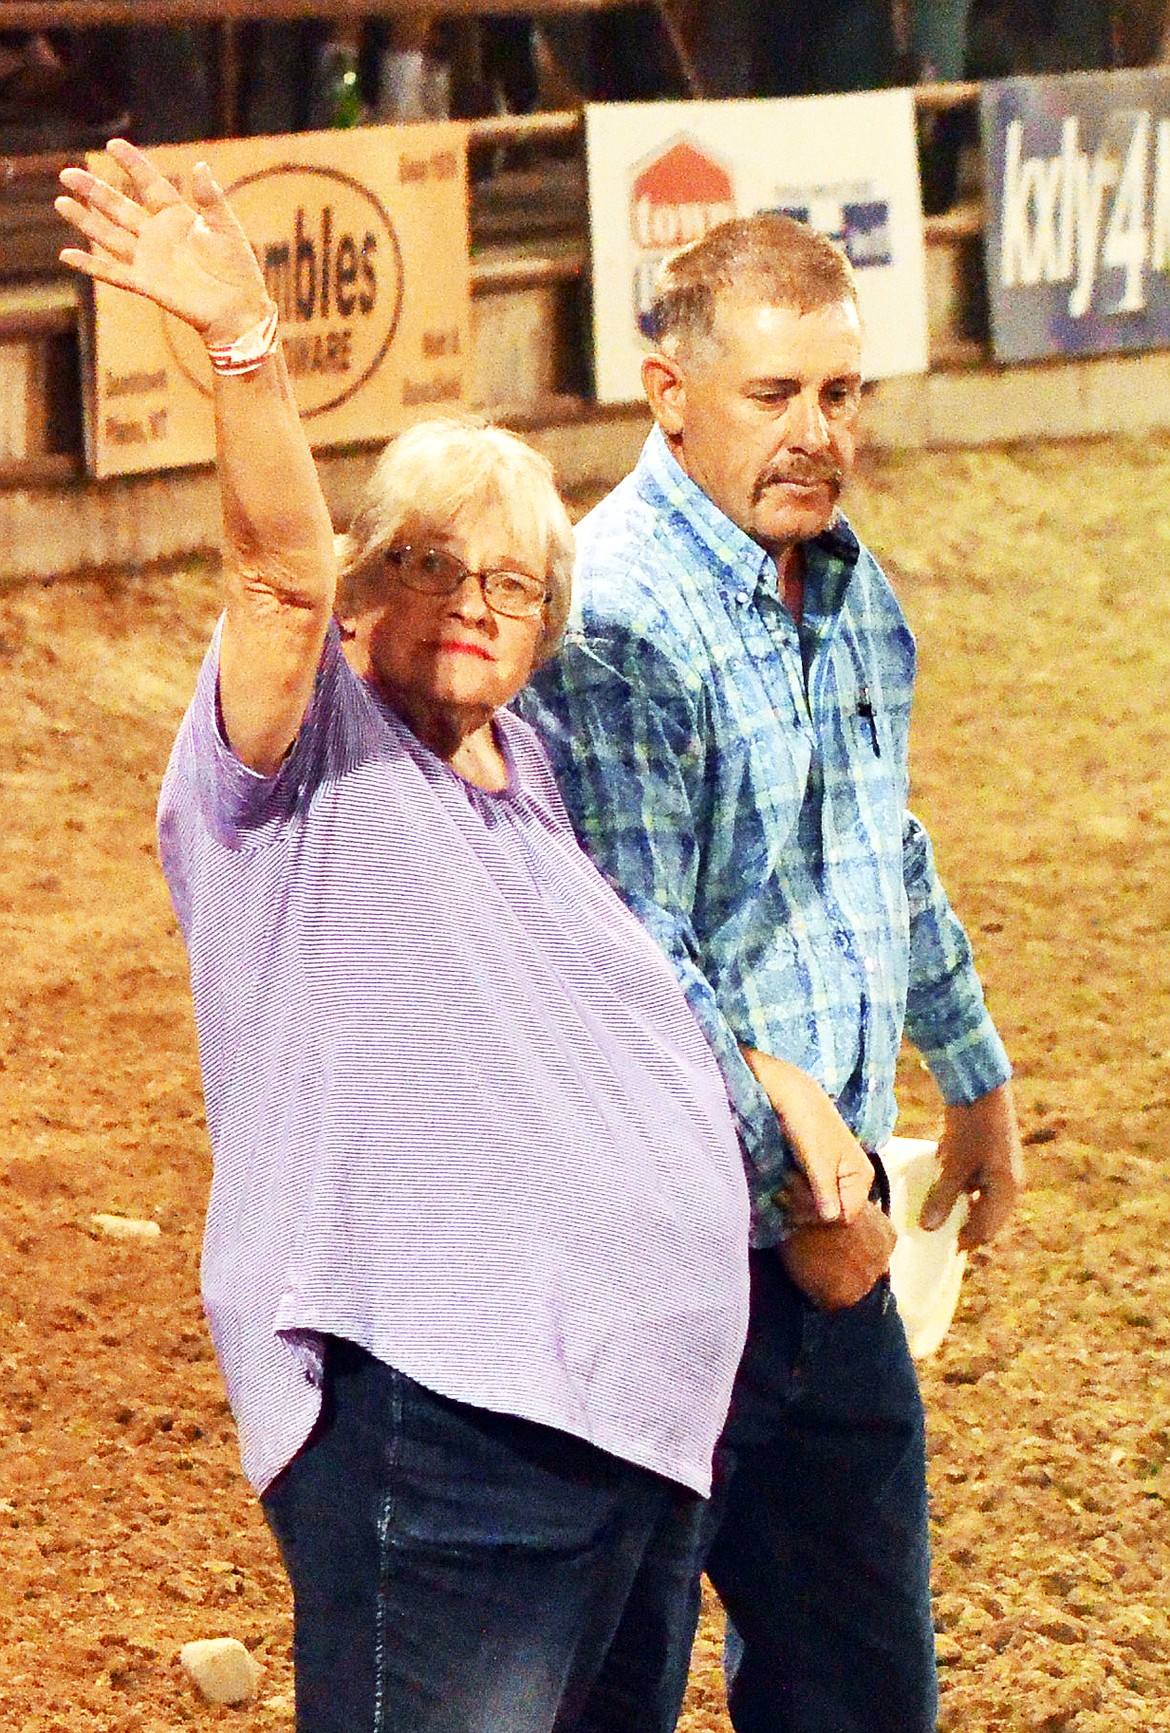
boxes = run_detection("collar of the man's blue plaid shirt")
[638,426,861,613]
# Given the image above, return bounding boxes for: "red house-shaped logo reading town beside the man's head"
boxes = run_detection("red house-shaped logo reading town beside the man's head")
[629,137,735,336]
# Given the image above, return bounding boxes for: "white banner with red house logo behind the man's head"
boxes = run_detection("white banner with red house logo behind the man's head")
[586,90,927,404]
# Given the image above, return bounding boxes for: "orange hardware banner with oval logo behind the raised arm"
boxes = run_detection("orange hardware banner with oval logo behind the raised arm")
[85,123,471,477]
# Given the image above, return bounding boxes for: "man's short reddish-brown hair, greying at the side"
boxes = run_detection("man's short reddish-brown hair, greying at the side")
[648,211,858,365]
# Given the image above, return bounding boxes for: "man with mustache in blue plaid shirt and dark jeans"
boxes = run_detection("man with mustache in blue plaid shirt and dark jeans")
[523,213,1021,1733]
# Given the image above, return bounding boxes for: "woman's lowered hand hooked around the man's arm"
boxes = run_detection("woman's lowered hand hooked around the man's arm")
[740,1047,874,1222]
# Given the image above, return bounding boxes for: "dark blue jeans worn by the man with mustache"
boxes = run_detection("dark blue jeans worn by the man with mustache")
[707,1251,938,1733]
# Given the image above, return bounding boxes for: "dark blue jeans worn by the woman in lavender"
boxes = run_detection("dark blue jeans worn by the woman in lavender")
[263,1340,705,1733]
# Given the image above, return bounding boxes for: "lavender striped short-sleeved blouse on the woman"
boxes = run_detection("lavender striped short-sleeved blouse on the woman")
[159,631,747,1492]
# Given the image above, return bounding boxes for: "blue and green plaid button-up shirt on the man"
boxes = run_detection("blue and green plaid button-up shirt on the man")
[518,430,1011,1246]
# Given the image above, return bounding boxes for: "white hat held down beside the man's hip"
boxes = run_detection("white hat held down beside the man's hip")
[879,1137,967,1360]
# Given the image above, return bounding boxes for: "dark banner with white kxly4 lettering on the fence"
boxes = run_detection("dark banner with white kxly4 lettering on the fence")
[981,69,1170,360]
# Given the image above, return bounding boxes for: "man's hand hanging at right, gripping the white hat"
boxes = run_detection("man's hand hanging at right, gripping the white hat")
[919,1083,1024,1251]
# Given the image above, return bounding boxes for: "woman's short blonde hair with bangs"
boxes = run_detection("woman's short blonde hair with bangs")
[336,416,574,667]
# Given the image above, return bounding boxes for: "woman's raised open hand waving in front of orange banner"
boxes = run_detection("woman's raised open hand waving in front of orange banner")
[55,139,272,345]
